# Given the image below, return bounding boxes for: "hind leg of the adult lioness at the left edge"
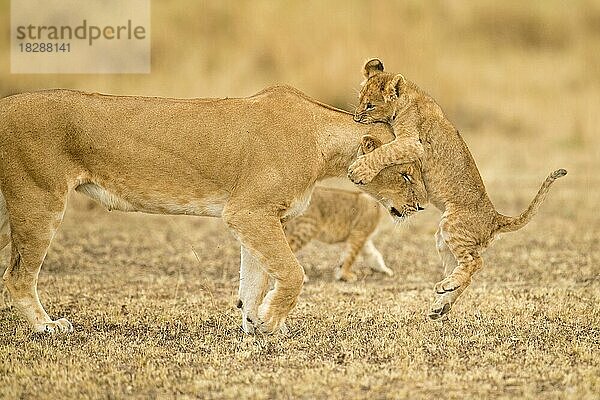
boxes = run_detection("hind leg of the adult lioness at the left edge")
[3,190,73,333]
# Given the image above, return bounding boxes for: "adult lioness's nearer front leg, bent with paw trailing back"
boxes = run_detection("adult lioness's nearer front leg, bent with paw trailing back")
[223,206,304,333]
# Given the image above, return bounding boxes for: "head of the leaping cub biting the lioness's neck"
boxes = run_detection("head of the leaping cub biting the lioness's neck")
[354,58,419,124]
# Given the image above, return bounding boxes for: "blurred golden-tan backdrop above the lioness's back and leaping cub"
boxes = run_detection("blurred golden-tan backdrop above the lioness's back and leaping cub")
[0,0,600,188]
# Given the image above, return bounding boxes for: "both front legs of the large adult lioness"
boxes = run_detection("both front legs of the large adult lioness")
[223,205,304,333]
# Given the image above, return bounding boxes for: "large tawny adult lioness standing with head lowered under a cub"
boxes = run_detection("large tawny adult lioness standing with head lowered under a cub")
[0,86,426,332]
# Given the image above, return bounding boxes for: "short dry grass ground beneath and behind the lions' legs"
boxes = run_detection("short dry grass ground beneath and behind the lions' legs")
[0,164,600,399]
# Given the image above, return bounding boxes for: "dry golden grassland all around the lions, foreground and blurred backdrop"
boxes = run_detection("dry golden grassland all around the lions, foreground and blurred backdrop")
[0,0,600,399]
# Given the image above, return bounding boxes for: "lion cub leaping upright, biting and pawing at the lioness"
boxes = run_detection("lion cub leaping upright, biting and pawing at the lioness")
[349,59,567,319]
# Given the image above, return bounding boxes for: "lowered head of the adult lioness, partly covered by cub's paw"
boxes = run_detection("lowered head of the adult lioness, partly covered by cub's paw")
[358,135,427,220]
